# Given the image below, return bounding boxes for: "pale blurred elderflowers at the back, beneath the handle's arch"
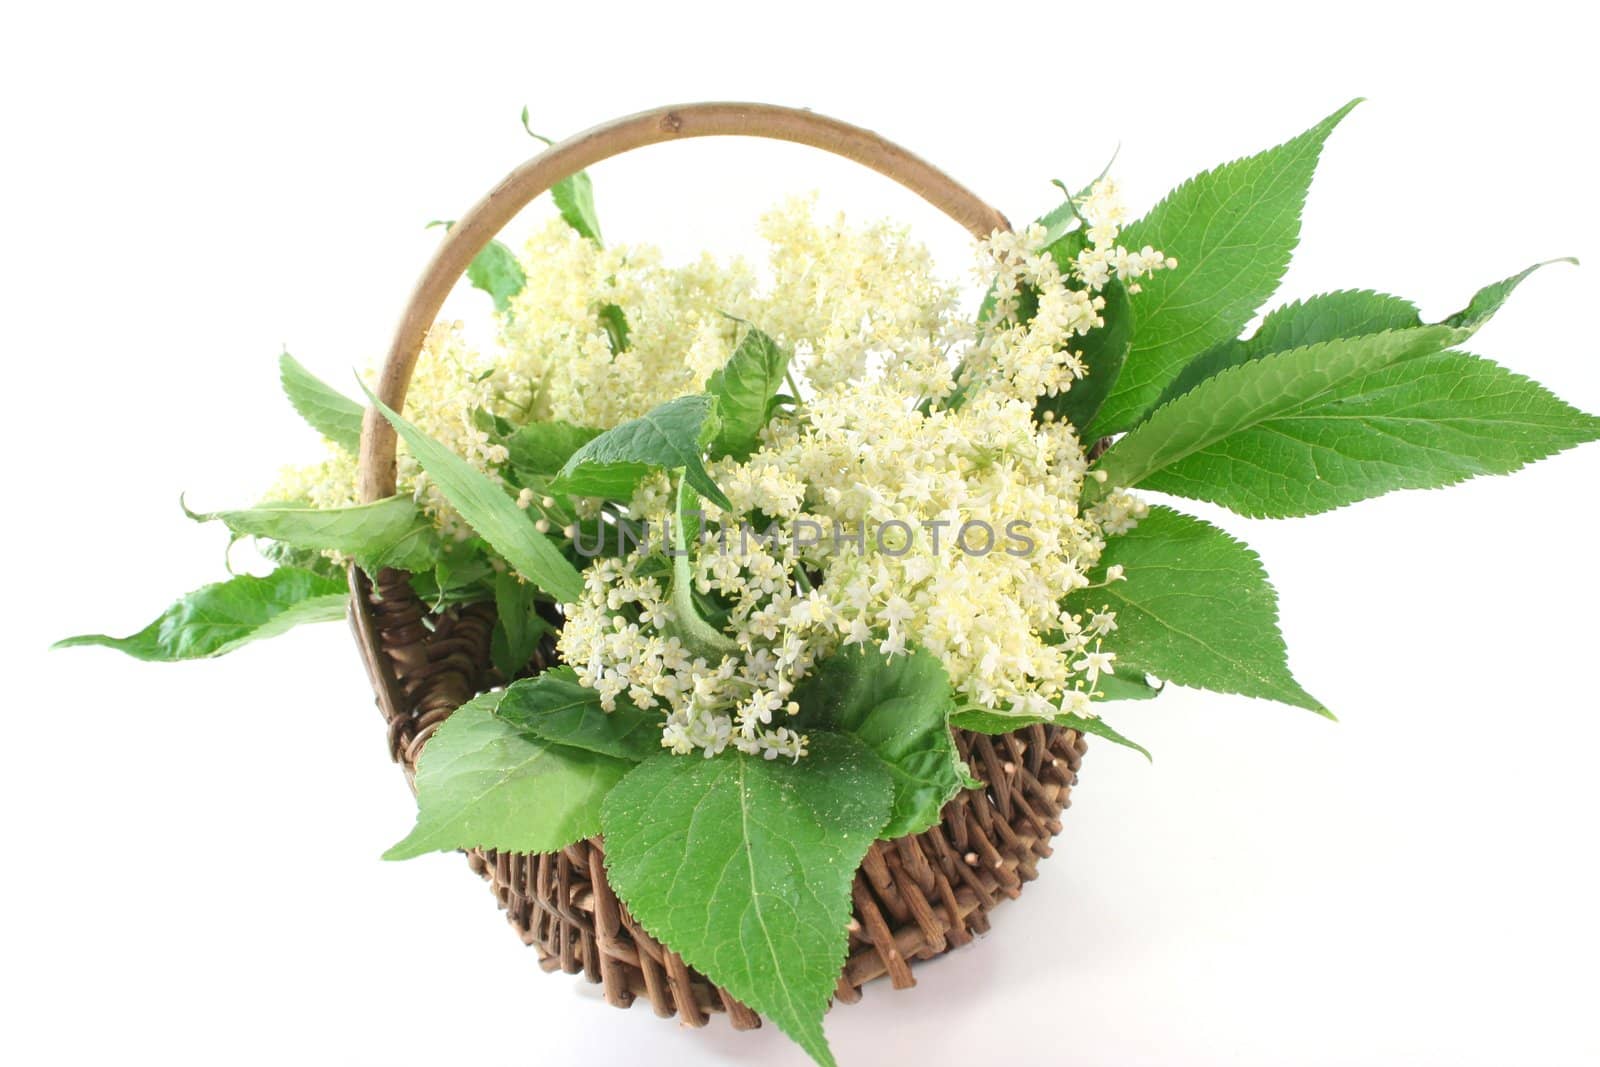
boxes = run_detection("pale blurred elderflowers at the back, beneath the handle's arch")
[266,198,955,518]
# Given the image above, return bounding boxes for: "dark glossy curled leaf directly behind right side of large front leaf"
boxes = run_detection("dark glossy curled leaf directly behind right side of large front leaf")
[794,646,971,840]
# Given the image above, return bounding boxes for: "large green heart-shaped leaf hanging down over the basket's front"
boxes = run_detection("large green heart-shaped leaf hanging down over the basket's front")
[602,733,893,1067]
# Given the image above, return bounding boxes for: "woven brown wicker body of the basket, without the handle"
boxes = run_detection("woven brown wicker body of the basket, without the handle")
[350,569,1085,1030]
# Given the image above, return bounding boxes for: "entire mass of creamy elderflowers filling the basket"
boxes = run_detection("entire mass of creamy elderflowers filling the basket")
[274,179,1176,758]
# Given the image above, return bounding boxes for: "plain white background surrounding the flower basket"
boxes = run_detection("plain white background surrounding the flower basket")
[0,2,1600,1065]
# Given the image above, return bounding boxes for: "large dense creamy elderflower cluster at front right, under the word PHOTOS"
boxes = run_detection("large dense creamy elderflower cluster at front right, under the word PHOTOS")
[768,389,1102,715]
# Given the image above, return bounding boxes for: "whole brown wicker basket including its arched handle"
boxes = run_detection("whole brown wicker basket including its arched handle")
[350,104,1083,1030]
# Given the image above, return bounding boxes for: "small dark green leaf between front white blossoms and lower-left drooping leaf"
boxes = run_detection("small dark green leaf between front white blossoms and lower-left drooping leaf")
[494,667,661,763]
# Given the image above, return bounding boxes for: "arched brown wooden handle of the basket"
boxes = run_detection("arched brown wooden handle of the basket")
[360,104,1011,501]
